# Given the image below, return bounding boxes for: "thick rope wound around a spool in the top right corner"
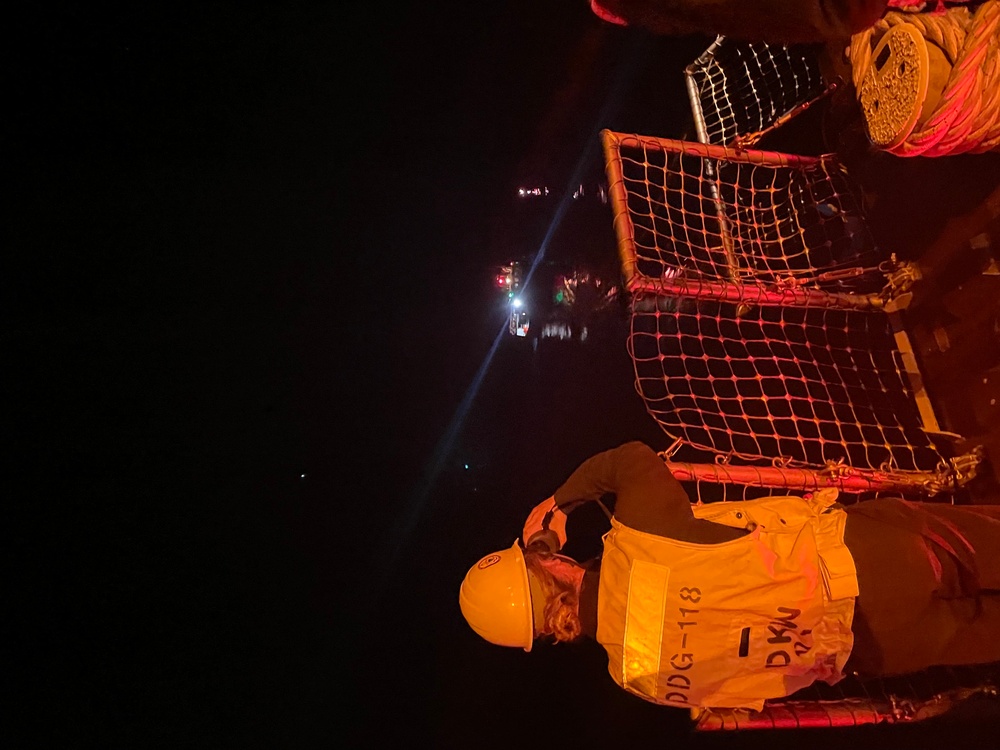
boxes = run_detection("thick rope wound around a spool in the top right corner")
[848,0,1000,156]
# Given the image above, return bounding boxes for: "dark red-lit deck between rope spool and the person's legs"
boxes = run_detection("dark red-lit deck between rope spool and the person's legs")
[844,106,1000,503]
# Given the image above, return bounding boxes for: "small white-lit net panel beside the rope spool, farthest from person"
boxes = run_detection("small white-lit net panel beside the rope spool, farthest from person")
[684,36,833,146]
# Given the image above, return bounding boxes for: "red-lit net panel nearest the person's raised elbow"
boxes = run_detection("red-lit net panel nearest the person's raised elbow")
[628,296,942,471]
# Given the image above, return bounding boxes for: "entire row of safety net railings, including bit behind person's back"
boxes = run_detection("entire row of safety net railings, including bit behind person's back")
[602,37,1000,731]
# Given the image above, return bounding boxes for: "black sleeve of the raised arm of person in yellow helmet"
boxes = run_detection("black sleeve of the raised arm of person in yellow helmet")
[555,441,746,544]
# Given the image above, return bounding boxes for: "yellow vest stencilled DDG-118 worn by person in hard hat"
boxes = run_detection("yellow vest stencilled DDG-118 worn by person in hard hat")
[597,490,858,710]
